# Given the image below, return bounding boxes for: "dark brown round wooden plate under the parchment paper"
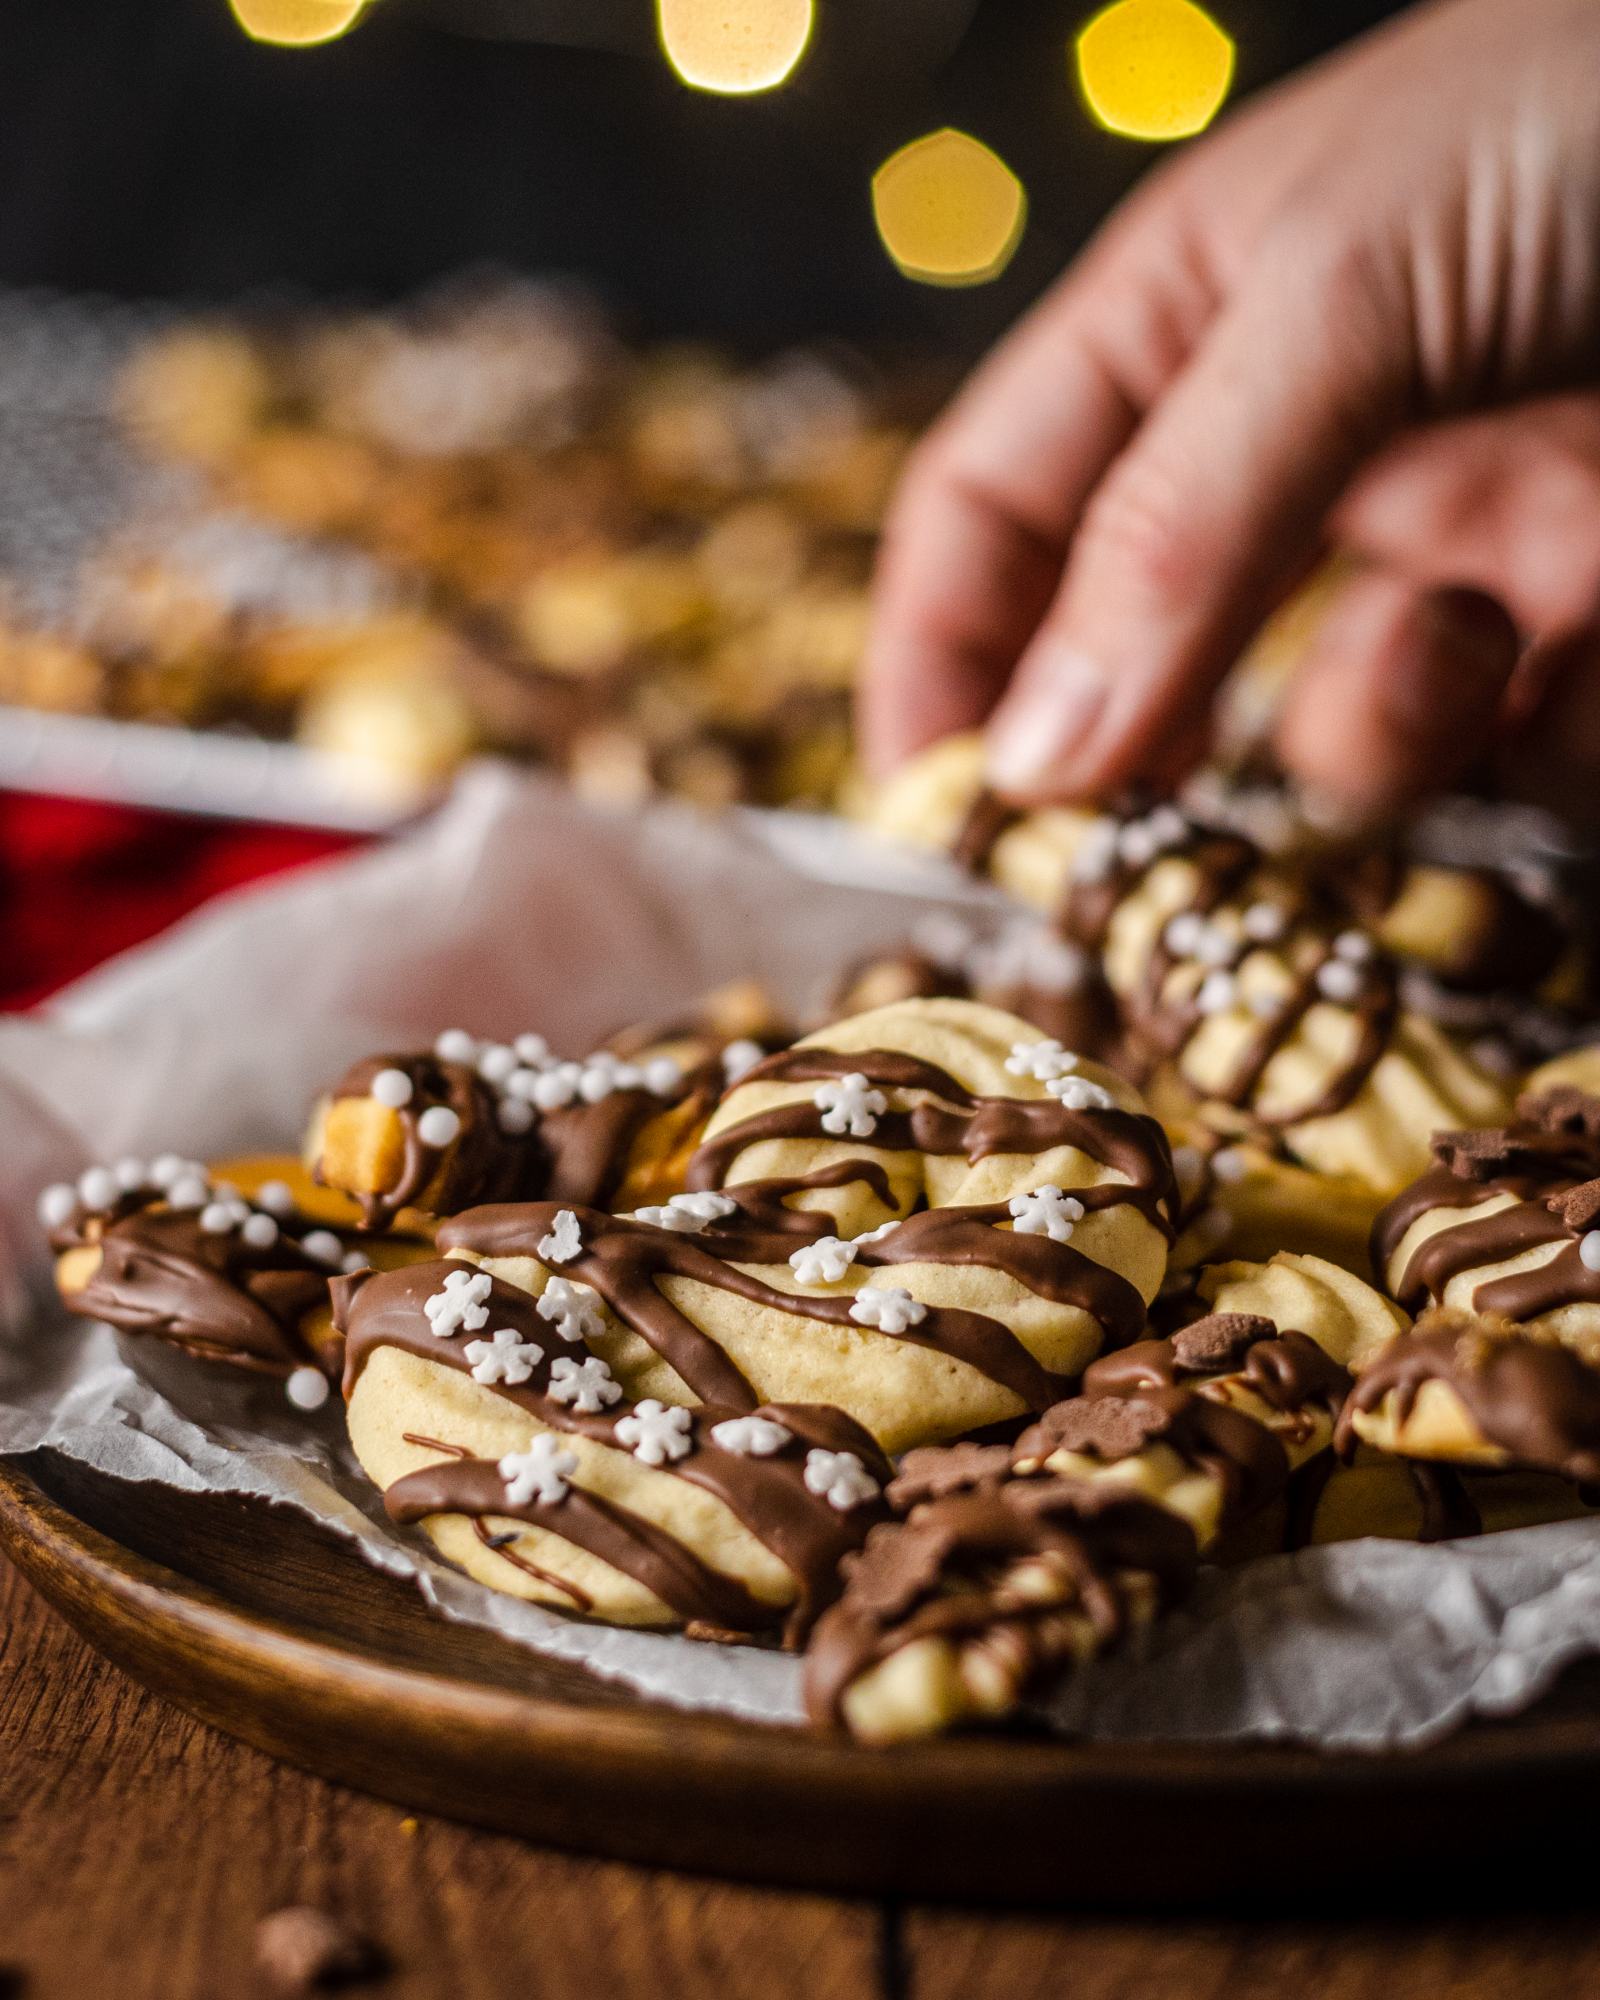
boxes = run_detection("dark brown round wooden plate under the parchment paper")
[0,1456,1600,1908]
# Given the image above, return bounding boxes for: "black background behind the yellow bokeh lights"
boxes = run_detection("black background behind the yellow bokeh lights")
[0,0,1394,354]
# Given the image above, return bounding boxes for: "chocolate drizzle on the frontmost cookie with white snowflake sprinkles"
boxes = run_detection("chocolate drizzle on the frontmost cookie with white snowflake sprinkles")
[334,1264,892,1644]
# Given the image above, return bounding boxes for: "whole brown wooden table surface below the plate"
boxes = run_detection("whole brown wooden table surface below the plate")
[0,1560,1600,2000]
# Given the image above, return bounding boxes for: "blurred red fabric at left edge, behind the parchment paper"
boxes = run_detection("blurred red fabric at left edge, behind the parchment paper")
[0,792,358,1008]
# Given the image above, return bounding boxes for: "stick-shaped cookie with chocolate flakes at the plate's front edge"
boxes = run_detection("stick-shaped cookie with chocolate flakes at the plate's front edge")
[806,1260,1392,1740]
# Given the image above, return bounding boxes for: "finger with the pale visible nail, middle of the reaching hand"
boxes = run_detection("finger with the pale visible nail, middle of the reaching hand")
[988,238,1412,798]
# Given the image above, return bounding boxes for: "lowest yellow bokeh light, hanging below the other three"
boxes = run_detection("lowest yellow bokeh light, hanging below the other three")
[872,126,1028,284]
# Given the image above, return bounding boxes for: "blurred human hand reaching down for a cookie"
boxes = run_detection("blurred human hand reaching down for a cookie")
[862,0,1600,816]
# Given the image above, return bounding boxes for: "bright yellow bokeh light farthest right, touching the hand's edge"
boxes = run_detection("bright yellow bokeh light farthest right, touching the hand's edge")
[1078,0,1234,140]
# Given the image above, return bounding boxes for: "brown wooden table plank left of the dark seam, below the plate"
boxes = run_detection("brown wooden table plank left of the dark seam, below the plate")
[0,1560,882,2000]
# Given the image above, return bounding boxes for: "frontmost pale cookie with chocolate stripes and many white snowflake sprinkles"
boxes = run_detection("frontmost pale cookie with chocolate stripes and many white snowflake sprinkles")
[334,1262,890,1644]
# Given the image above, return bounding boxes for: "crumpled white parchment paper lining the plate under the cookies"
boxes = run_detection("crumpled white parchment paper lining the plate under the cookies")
[0,768,1600,1748]
